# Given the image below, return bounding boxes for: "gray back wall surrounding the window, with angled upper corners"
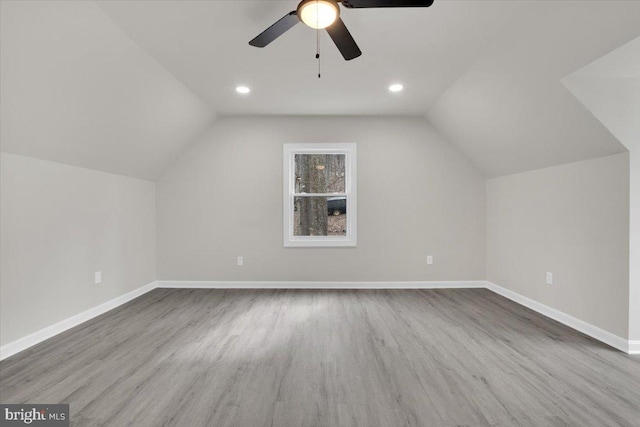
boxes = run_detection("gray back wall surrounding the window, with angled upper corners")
[157,117,486,281]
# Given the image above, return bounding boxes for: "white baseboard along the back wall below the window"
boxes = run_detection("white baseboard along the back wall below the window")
[156,280,486,289]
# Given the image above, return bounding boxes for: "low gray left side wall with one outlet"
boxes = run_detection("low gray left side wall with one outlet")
[0,153,156,345]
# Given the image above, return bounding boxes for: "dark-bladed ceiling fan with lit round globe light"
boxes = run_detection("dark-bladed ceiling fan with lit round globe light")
[249,0,433,61]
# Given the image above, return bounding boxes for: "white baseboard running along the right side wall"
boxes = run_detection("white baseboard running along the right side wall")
[486,282,630,353]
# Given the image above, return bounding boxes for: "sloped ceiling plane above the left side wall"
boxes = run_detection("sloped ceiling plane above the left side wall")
[0,1,214,180]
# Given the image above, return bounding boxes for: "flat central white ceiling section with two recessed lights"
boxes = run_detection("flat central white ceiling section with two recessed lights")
[97,0,517,115]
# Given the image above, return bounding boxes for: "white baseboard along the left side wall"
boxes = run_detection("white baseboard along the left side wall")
[0,282,156,360]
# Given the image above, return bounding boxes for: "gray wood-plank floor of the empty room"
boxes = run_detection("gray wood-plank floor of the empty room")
[0,289,640,427]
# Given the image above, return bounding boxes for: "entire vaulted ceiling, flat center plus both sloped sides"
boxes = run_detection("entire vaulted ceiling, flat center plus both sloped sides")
[0,0,640,180]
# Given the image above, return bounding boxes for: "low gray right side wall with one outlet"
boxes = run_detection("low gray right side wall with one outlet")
[486,153,629,338]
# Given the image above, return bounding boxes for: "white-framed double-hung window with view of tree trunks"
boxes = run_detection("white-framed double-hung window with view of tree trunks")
[283,144,357,246]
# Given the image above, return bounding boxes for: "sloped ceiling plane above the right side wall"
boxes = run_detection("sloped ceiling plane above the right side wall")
[427,1,640,177]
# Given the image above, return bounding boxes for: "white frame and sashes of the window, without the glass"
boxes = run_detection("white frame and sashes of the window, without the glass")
[282,143,358,247]
